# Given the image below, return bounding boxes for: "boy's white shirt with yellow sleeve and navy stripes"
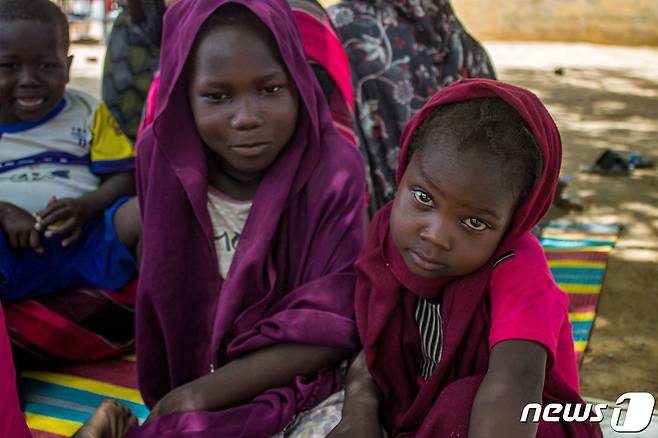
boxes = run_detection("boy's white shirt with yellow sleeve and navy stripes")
[0,89,135,213]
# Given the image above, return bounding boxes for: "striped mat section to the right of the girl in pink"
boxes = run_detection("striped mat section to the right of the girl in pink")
[539,221,621,363]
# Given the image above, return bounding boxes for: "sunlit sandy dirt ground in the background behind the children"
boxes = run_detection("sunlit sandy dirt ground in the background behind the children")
[72,43,658,401]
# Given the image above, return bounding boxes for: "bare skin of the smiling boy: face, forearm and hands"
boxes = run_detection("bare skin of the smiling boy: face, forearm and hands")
[0,20,135,250]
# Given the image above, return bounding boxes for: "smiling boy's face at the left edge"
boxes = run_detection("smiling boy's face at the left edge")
[0,20,72,124]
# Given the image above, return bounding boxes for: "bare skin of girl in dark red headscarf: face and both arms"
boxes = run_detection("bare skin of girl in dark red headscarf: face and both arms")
[330,142,547,438]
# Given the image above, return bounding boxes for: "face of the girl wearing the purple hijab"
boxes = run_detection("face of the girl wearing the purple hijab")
[189,25,299,181]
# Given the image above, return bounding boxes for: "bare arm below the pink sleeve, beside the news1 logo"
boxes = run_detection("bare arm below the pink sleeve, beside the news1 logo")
[468,340,547,438]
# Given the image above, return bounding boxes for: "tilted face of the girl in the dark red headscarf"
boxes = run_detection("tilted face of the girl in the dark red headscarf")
[390,145,516,279]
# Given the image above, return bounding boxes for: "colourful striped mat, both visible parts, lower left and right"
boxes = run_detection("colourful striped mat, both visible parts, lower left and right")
[21,222,620,438]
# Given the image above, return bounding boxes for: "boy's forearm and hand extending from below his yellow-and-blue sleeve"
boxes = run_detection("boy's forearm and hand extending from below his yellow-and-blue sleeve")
[35,172,135,246]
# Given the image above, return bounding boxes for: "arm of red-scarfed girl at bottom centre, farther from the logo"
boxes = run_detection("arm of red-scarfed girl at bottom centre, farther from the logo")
[327,350,382,438]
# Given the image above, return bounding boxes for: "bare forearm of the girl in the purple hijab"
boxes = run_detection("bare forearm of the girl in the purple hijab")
[148,344,350,420]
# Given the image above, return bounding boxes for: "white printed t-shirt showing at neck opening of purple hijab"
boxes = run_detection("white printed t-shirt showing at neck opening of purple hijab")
[208,188,251,279]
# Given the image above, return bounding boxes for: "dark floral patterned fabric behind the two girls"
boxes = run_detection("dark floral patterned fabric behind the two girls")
[329,0,495,215]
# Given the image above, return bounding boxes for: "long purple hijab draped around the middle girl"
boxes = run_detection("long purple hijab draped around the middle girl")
[131,0,365,437]
